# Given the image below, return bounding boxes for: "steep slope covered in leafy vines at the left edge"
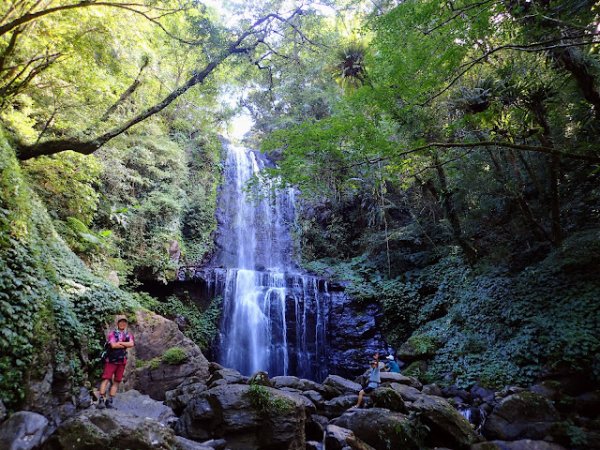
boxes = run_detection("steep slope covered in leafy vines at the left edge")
[0,136,137,409]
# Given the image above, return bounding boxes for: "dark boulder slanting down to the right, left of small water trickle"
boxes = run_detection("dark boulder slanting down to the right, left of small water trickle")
[410,395,479,448]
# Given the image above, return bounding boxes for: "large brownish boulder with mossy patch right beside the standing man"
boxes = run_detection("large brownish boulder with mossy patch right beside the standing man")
[126,310,208,400]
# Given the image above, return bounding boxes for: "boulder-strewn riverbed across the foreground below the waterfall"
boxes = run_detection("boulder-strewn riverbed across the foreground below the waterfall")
[0,312,600,450]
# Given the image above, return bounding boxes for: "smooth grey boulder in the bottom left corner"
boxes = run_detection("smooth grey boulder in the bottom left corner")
[0,411,48,450]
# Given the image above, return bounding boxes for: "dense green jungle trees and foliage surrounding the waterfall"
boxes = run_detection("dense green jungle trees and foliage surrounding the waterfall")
[0,0,600,414]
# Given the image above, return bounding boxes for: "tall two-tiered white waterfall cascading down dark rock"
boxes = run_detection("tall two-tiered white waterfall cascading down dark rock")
[202,144,330,380]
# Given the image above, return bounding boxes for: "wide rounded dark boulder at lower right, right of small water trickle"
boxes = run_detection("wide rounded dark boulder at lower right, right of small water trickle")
[482,392,560,441]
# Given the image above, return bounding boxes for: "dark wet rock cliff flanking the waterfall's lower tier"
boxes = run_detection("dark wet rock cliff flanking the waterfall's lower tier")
[175,268,387,381]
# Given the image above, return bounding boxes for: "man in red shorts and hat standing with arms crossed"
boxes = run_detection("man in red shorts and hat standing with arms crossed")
[98,317,134,409]
